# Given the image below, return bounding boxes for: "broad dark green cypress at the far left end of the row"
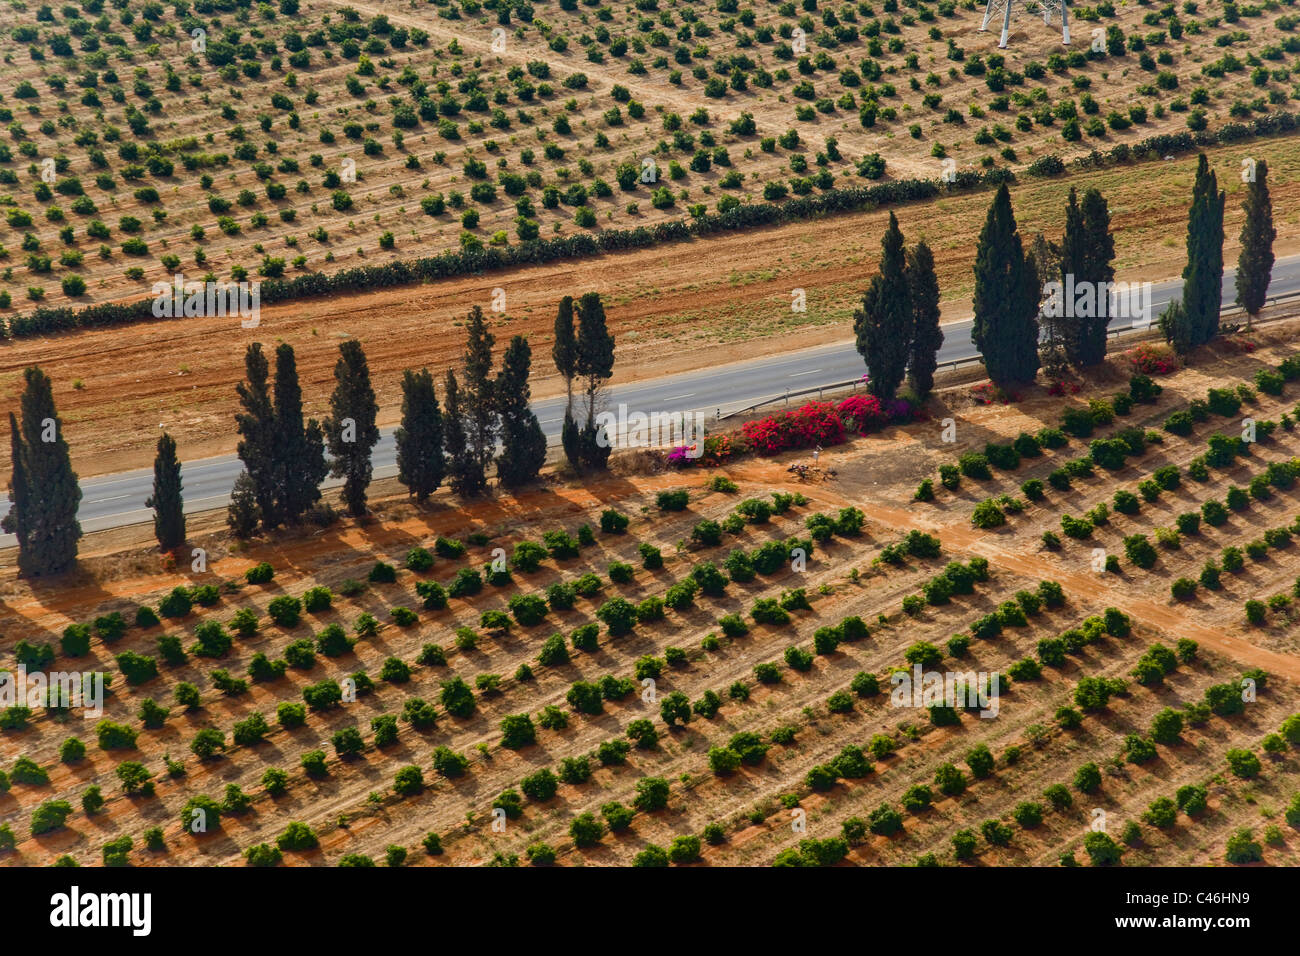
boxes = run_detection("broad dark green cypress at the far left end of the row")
[3,367,82,578]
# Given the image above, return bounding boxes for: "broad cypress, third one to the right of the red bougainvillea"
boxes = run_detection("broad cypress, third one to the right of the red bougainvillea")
[971,183,1040,385]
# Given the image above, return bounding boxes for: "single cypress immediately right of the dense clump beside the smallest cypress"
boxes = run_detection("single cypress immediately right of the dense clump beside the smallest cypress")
[325,338,380,518]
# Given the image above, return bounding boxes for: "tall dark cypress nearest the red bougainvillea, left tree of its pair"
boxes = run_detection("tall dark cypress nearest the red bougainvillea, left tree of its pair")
[853,212,913,401]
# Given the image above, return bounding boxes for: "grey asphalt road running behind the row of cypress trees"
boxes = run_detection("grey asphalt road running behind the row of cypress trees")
[0,256,1300,548]
